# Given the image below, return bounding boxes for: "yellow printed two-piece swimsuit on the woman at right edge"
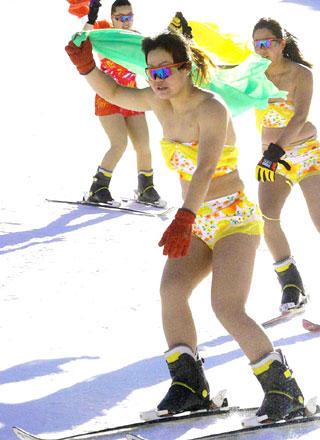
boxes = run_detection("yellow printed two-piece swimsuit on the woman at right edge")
[255,101,320,186]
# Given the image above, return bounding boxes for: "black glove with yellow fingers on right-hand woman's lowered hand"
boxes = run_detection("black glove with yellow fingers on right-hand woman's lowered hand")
[256,144,291,182]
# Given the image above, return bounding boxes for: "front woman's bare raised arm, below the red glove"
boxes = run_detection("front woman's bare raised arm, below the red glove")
[85,67,153,111]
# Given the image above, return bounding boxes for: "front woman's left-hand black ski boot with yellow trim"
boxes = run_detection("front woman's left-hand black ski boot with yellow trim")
[157,345,213,414]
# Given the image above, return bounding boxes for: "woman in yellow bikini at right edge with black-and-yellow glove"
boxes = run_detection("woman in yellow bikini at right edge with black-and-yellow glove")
[253,18,320,313]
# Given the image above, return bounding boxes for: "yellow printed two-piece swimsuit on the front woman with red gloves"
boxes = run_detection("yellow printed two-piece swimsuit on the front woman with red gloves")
[161,139,263,249]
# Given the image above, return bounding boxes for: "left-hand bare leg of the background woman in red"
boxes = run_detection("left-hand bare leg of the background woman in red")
[99,113,128,171]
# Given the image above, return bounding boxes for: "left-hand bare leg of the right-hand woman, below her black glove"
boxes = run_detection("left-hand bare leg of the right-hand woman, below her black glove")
[259,175,291,261]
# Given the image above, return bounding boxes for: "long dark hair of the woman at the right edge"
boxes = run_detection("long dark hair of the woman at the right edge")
[252,18,312,67]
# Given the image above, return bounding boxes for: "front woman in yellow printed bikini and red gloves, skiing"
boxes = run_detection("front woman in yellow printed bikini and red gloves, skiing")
[66,26,304,422]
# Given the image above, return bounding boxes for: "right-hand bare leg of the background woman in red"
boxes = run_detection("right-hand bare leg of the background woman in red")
[125,115,152,171]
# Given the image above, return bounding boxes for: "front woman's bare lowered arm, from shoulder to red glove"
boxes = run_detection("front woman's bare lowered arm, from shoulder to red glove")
[183,101,228,213]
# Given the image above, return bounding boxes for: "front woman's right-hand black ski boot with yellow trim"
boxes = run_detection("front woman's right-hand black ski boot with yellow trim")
[251,350,304,423]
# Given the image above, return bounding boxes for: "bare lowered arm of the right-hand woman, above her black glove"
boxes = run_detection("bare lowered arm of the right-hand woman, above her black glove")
[276,68,313,148]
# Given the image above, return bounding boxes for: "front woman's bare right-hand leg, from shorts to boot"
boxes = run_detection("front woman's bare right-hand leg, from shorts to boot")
[211,234,273,362]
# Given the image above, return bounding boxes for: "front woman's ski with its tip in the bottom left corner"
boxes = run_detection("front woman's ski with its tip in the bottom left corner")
[13,406,258,440]
